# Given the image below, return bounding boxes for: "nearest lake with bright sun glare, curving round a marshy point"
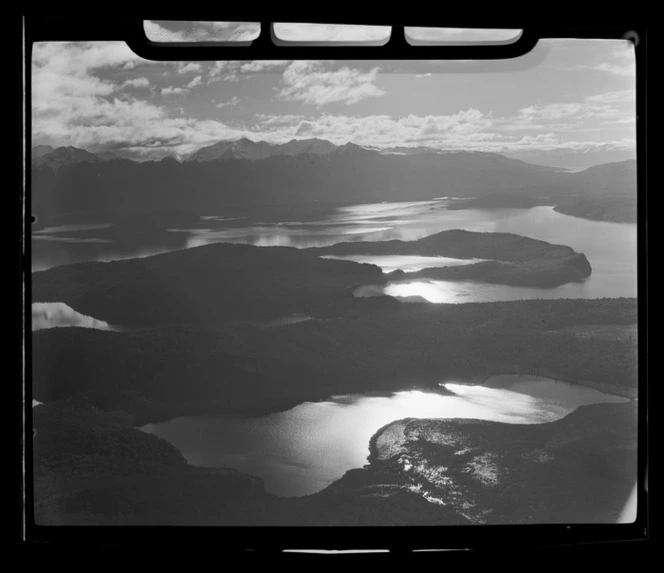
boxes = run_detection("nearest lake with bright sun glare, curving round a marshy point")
[141,376,626,496]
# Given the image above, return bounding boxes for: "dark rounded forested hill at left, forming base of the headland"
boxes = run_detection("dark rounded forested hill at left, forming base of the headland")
[32,243,385,325]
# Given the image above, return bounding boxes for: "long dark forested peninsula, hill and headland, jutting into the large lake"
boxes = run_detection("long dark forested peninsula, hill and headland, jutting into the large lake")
[32,230,591,326]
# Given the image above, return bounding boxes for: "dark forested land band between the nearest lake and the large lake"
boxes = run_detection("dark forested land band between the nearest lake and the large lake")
[32,297,637,423]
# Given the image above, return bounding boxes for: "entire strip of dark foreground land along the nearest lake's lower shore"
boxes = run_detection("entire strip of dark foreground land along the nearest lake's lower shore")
[33,401,636,526]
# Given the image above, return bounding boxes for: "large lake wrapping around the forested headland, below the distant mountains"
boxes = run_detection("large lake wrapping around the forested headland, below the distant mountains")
[32,198,637,303]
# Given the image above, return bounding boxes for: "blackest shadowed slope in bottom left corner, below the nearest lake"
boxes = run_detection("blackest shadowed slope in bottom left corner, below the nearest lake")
[33,401,467,526]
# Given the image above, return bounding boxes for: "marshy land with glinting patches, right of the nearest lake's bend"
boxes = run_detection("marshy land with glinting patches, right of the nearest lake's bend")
[325,402,637,524]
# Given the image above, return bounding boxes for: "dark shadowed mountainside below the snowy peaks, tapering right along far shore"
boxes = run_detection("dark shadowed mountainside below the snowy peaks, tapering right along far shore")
[31,144,560,227]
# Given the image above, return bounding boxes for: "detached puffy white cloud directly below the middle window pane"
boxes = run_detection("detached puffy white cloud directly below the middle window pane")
[278,61,385,107]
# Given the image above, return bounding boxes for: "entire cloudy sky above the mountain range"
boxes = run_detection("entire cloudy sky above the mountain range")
[32,23,635,159]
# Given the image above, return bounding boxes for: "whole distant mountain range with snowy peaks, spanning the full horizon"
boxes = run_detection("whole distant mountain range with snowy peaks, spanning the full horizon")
[30,138,636,224]
